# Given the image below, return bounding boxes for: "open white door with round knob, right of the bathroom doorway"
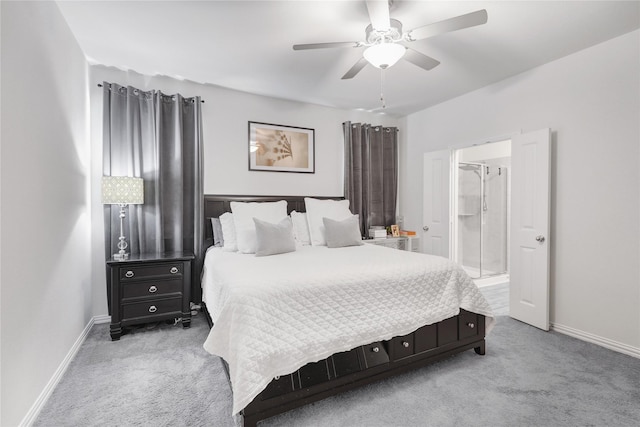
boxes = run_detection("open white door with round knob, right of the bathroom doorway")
[509,129,551,331]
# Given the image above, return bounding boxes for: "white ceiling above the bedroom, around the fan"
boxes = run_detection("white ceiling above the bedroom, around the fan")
[58,0,640,116]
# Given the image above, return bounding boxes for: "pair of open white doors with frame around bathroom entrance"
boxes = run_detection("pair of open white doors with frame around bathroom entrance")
[421,128,551,331]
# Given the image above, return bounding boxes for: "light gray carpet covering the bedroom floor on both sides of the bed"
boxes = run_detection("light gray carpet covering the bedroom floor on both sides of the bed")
[35,292,640,427]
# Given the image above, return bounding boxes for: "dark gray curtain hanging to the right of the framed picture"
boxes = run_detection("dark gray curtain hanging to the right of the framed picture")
[342,122,398,236]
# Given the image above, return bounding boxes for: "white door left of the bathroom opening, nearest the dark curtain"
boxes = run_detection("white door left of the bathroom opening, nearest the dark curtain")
[422,150,451,258]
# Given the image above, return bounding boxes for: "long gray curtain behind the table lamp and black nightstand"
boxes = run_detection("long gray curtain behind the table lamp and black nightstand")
[103,82,203,301]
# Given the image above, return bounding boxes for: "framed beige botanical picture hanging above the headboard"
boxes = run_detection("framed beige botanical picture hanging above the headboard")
[249,122,316,173]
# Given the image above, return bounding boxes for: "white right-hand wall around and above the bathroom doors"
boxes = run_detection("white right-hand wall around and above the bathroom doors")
[400,31,640,352]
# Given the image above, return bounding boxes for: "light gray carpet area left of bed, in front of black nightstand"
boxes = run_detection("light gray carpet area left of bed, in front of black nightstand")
[34,314,232,427]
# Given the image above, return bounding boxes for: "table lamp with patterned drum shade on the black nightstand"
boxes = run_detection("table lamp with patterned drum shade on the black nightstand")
[102,176,144,261]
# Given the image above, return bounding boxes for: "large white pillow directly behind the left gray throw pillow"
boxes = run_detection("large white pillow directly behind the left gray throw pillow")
[230,200,287,254]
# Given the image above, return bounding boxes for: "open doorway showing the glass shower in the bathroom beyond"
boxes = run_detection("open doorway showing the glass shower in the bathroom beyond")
[451,140,511,286]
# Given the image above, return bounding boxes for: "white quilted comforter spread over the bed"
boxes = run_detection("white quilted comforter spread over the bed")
[203,245,494,414]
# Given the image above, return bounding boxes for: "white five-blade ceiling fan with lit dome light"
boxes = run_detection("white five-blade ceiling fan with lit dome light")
[293,0,487,80]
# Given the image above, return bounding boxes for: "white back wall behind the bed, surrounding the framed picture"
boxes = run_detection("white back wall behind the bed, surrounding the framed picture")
[90,65,402,315]
